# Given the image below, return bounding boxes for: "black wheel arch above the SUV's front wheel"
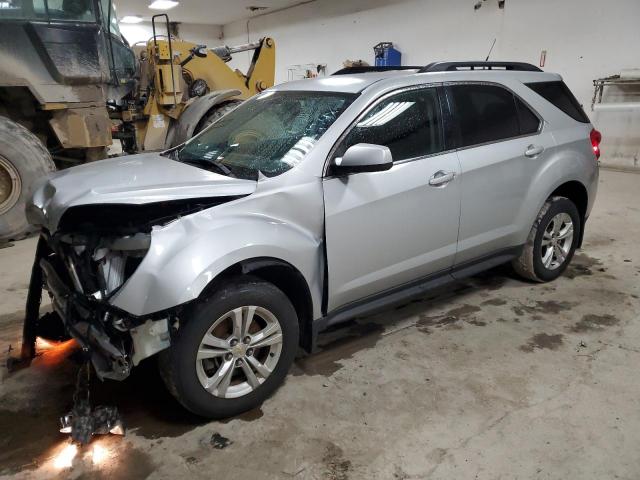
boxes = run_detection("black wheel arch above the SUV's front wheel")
[198,257,313,352]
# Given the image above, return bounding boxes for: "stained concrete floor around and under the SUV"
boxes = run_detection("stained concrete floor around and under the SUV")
[0,171,640,480]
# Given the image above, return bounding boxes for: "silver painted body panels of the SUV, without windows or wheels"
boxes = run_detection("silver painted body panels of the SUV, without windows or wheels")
[28,71,598,326]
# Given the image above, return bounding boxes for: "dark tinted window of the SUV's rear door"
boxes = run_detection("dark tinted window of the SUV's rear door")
[450,85,520,147]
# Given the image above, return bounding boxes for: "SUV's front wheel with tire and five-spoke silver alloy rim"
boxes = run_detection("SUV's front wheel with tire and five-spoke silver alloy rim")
[158,276,298,419]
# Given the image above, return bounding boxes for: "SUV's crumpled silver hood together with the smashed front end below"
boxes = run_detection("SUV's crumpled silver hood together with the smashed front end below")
[21,153,257,380]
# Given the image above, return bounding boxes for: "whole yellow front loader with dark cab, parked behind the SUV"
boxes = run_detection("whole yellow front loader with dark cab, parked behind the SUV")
[0,8,275,242]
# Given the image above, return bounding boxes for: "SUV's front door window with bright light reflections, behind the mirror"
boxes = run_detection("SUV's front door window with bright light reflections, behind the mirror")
[336,88,443,161]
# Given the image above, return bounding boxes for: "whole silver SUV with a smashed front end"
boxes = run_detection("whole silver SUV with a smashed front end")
[23,62,600,418]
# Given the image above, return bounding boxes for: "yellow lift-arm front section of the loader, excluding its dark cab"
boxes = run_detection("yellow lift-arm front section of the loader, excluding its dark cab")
[111,14,275,153]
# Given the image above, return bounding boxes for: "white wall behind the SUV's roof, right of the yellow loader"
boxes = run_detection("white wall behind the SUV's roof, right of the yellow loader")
[223,0,640,166]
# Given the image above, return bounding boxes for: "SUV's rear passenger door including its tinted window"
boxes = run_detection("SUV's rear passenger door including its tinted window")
[446,83,554,265]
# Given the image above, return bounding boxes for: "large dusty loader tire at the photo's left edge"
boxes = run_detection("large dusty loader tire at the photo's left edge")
[0,116,56,241]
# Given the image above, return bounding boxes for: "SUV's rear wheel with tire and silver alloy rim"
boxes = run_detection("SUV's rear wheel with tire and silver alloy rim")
[512,197,582,282]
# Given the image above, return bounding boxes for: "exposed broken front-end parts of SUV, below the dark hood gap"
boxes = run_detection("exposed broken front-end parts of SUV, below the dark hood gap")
[23,225,176,380]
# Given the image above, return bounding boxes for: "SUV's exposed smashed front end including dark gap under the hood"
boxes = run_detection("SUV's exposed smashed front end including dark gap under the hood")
[22,199,230,380]
